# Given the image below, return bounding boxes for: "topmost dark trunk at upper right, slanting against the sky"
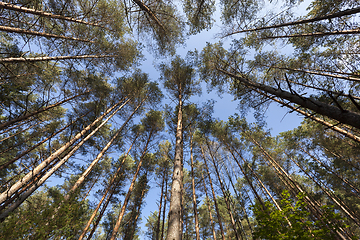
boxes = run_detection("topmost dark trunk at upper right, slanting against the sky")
[225,7,360,37]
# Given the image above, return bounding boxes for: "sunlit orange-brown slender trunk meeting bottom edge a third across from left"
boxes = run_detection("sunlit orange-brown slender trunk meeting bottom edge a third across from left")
[110,131,153,240]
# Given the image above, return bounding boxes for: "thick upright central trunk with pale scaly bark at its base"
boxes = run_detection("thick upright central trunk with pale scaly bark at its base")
[166,94,183,240]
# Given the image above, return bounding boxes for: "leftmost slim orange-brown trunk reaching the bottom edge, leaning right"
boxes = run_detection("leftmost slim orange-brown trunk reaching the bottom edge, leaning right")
[79,136,137,240]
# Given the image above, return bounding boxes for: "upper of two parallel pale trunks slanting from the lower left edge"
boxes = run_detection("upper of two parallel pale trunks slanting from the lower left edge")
[0,99,130,206]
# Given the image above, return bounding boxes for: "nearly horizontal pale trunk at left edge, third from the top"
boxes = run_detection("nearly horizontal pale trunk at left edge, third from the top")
[0,55,119,63]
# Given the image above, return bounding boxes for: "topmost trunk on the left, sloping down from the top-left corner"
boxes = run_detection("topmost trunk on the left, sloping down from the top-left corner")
[0,2,108,28]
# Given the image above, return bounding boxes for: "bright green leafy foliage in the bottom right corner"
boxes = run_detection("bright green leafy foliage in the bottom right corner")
[253,190,347,240]
